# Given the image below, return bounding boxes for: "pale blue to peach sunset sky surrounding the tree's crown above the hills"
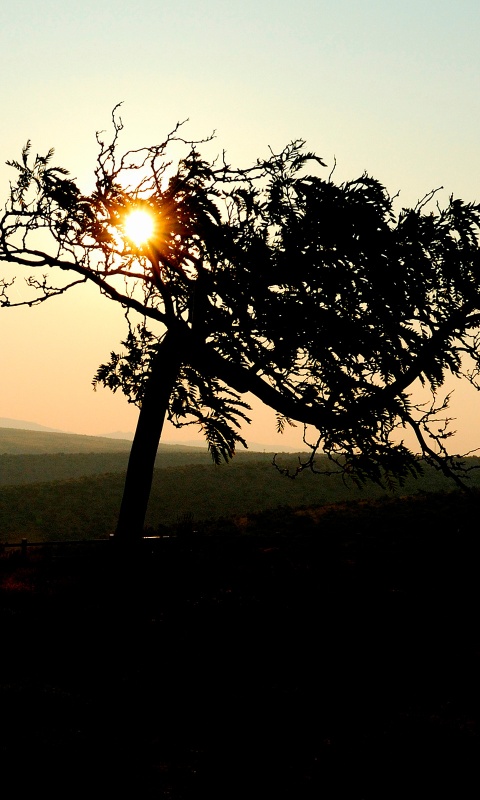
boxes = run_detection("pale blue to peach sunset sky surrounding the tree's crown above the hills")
[0,0,480,452]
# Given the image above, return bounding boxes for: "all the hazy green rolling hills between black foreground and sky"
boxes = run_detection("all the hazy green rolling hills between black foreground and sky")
[0,429,480,542]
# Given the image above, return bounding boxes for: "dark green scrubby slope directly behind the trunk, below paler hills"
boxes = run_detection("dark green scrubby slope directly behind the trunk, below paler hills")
[0,459,480,542]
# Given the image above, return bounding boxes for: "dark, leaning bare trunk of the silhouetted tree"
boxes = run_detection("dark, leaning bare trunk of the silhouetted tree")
[115,331,182,544]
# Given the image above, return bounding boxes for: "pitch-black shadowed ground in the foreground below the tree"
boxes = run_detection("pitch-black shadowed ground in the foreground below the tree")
[0,495,480,800]
